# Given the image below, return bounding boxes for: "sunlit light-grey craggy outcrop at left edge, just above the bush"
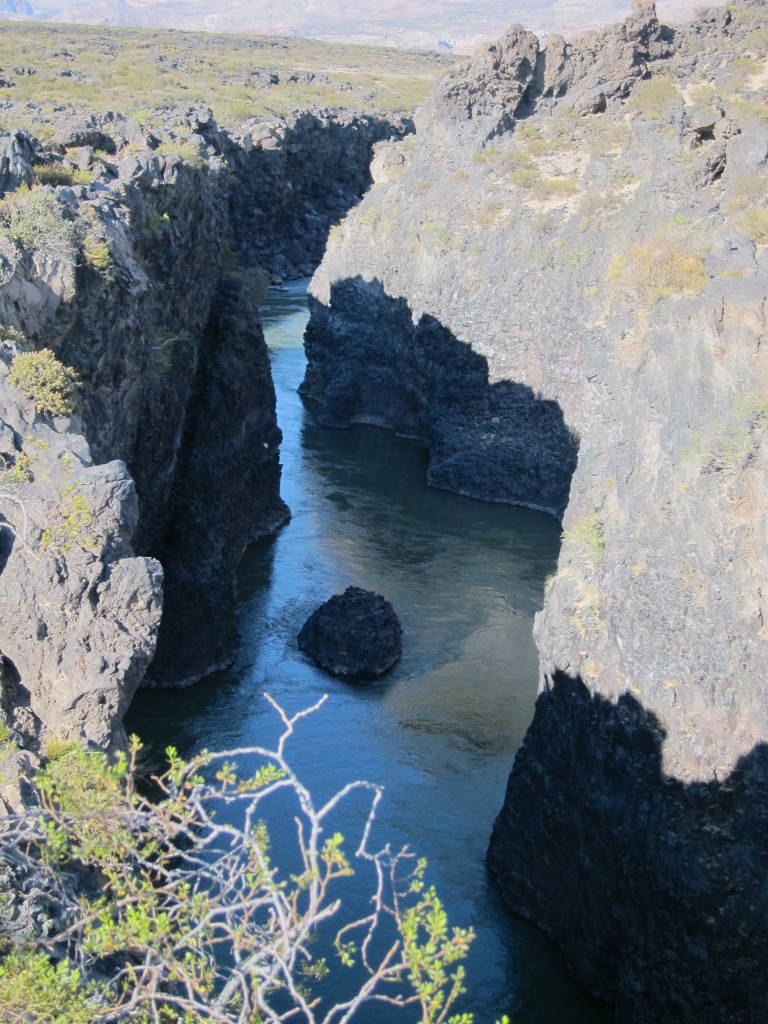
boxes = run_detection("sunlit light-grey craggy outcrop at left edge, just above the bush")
[0,345,163,746]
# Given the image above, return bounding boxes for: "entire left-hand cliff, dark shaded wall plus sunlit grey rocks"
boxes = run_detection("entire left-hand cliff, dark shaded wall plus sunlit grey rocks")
[0,109,410,774]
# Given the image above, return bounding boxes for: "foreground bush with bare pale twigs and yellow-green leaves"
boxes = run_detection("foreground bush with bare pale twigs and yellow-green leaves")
[0,698,481,1024]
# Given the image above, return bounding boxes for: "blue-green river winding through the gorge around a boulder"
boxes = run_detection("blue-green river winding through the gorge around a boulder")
[127,282,612,1024]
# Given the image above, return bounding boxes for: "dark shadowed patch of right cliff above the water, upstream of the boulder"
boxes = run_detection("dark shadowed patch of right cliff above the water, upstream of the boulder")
[300,278,578,515]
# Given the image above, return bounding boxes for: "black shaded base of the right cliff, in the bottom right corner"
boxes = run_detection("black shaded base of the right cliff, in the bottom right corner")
[488,674,768,1024]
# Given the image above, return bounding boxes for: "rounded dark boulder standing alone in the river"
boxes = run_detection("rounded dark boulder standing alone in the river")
[299,587,402,680]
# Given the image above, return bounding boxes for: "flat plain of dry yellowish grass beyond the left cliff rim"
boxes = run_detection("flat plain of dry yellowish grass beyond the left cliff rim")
[0,22,455,129]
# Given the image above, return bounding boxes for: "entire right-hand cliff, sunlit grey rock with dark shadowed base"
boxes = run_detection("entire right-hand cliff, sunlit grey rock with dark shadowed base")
[302,2,768,1024]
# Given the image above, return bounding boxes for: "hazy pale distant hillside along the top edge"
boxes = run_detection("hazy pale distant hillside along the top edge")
[0,0,729,52]
